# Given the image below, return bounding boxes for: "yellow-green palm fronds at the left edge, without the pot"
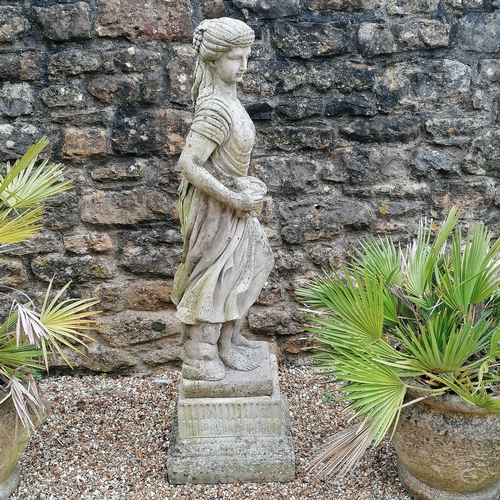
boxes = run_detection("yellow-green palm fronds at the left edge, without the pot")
[0,138,97,429]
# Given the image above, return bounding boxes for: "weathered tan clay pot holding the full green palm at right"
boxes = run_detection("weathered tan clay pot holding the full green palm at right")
[392,391,500,500]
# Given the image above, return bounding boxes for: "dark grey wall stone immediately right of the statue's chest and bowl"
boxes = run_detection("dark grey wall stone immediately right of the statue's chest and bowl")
[252,155,320,199]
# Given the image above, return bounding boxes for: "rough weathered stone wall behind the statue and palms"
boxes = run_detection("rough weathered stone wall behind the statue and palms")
[0,0,500,371]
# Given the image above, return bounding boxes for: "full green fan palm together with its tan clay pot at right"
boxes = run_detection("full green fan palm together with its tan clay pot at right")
[298,207,500,500]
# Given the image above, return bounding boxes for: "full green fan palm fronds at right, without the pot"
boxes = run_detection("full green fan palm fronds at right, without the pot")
[298,207,500,475]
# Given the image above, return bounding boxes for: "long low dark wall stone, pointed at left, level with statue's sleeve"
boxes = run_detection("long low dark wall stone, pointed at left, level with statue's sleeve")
[340,116,420,142]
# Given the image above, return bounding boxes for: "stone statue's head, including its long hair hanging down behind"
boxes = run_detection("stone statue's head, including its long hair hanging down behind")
[192,17,255,104]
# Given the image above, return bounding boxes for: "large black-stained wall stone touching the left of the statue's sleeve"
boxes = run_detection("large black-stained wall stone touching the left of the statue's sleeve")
[113,109,192,154]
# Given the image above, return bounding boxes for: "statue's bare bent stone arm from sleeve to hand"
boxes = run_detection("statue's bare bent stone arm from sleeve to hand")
[179,130,265,212]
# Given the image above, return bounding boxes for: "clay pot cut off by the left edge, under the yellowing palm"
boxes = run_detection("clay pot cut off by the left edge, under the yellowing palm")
[0,399,50,500]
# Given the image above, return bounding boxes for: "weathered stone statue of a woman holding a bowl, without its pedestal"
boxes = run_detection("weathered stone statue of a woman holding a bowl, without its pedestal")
[172,17,274,380]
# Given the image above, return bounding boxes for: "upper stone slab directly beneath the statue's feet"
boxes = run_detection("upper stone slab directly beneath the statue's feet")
[182,342,273,398]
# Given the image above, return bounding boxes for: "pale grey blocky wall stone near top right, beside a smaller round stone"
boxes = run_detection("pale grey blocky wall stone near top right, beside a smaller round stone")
[397,17,451,50]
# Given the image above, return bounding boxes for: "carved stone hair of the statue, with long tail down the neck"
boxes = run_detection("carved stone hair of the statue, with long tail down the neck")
[191,17,255,106]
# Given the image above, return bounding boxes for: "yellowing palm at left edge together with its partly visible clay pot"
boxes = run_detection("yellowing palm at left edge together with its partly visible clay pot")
[0,138,96,500]
